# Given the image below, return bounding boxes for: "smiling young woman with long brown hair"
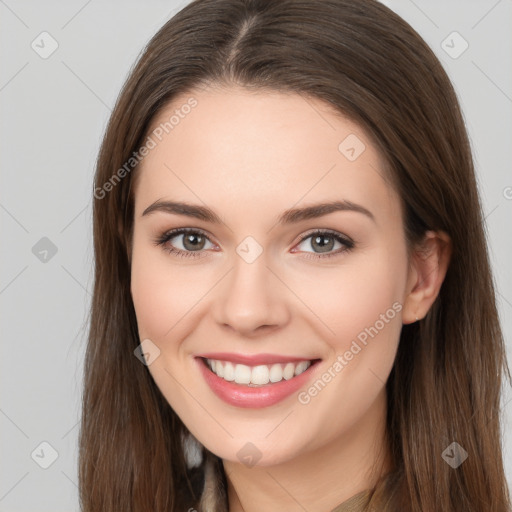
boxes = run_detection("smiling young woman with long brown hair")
[80,0,510,512]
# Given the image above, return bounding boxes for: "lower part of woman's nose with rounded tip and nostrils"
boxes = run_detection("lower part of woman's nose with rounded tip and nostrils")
[213,251,290,338]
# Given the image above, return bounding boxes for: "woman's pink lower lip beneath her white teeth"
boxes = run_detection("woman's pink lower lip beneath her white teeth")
[196,357,318,409]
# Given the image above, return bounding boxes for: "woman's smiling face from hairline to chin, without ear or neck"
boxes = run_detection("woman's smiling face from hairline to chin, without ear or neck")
[131,88,409,465]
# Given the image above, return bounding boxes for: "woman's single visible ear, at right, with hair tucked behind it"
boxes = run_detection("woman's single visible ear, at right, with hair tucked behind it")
[402,231,452,324]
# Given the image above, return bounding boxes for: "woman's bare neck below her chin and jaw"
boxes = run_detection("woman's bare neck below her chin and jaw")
[223,388,391,512]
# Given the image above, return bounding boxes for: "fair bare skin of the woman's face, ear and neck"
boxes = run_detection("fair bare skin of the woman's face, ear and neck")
[131,87,450,512]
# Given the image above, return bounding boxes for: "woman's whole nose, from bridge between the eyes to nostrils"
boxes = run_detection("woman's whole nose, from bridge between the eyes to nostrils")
[216,241,288,334]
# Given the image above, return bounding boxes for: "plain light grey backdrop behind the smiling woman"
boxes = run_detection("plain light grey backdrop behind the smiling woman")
[0,0,512,512]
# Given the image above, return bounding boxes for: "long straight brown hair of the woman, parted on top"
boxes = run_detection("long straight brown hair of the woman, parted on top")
[79,0,510,512]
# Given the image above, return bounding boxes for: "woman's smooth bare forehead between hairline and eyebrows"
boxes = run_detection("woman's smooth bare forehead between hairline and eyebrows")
[135,88,399,226]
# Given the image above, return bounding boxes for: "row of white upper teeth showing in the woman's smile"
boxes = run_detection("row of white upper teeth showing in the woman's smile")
[206,359,311,386]
